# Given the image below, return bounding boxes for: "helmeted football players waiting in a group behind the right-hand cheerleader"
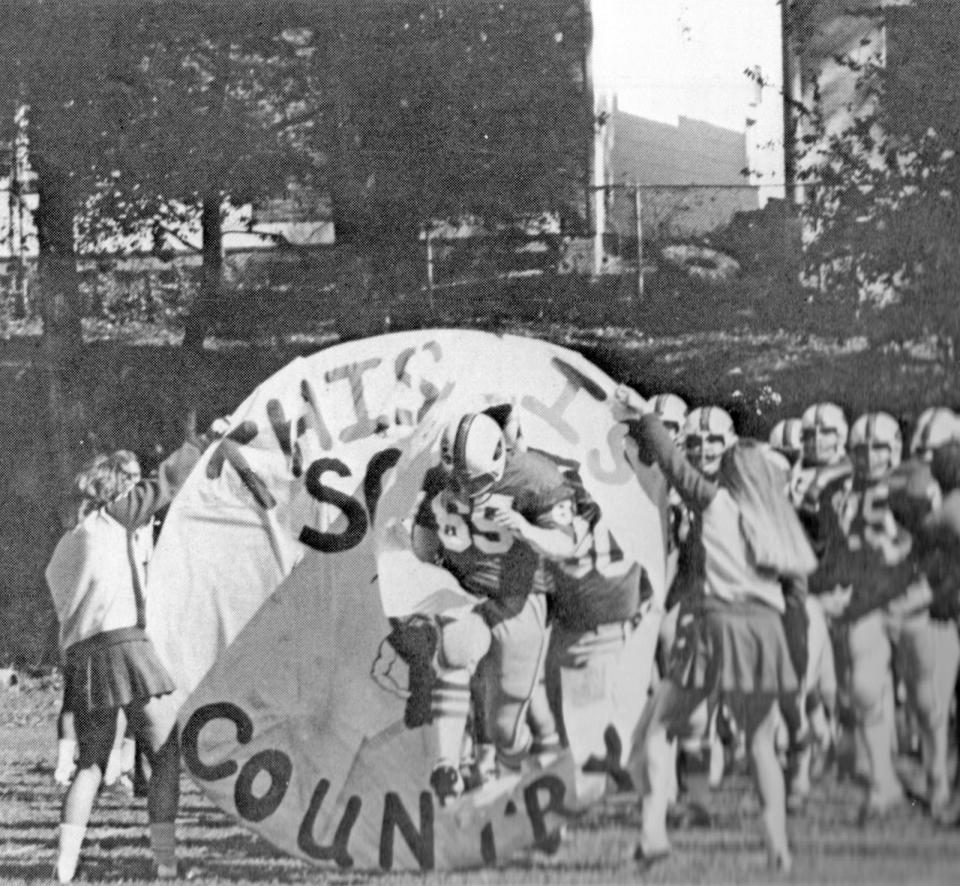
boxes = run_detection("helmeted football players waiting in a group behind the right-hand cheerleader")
[632,395,960,858]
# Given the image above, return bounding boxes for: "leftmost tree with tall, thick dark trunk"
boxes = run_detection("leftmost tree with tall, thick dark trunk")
[0,0,150,535]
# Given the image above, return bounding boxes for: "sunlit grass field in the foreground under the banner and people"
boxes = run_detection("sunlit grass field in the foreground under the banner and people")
[0,679,960,886]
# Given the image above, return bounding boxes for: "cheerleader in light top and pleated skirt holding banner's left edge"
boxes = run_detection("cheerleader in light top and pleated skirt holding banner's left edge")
[46,443,200,883]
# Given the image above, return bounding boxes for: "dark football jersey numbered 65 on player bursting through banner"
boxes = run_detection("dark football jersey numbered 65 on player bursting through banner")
[415,451,574,598]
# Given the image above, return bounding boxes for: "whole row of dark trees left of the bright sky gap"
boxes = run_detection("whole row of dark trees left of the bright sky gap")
[0,0,590,528]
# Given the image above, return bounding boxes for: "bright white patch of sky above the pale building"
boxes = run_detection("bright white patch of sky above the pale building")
[592,0,783,196]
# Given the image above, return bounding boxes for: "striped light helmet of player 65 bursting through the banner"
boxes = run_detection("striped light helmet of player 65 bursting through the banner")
[440,412,507,503]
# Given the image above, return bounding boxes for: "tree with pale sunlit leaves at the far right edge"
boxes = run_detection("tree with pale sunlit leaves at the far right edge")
[803,0,960,355]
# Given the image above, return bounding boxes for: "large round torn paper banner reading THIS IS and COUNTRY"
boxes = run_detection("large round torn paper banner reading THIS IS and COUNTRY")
[147,330,664,870]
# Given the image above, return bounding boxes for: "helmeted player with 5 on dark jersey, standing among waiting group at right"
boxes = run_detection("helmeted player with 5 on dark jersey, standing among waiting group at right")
[810,412,912,822]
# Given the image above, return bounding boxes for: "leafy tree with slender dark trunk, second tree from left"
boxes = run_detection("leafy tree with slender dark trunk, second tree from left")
[92,0,330,352]
